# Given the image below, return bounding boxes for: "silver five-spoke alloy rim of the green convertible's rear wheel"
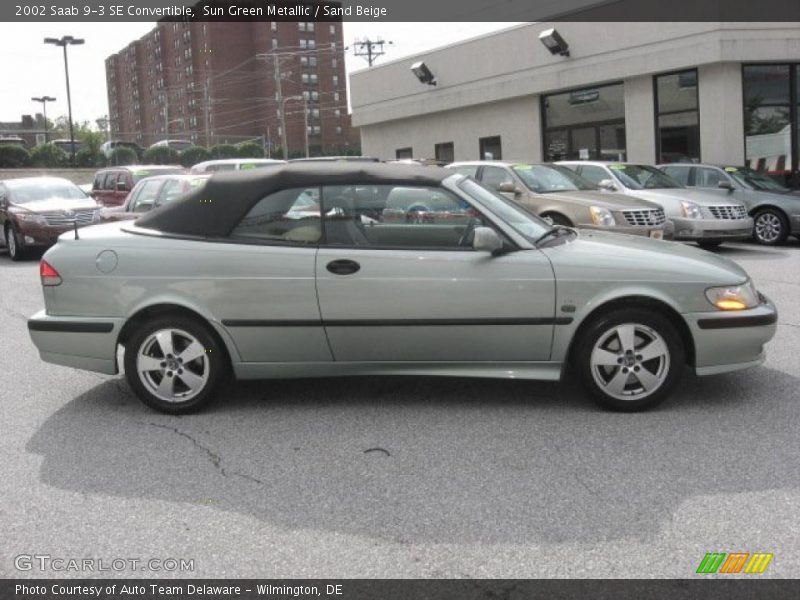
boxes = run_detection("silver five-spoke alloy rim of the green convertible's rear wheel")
[136,329,210,402]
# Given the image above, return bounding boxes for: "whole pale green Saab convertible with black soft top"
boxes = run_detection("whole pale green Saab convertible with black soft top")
[28,164,777,413]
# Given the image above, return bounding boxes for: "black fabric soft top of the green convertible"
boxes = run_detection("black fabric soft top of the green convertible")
[135,162,454,237]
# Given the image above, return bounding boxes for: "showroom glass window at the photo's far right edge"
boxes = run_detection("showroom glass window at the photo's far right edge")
[742,64,800,186]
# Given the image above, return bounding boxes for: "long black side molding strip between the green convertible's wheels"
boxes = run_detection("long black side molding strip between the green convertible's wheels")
[222,317,572,327]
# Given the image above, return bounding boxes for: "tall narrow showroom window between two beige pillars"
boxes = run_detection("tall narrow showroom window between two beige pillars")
[654,69,700,163]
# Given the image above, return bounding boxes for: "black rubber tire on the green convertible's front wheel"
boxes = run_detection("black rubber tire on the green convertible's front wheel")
[574,308,686,412]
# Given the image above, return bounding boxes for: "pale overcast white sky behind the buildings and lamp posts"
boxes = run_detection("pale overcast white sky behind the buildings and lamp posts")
[0,22,515,125]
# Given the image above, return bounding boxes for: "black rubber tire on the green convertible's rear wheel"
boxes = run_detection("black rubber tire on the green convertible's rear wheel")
[125,315,228,415]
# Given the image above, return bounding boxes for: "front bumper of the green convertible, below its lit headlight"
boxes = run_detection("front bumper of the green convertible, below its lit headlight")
[684,298,778,375]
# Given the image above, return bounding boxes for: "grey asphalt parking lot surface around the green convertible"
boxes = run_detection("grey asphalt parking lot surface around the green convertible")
[0,240,800,578]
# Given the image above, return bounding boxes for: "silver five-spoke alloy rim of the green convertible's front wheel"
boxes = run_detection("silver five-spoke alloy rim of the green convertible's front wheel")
[590,323,670,400]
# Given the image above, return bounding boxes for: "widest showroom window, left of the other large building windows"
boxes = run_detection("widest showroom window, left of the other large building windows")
[542,83,627,161]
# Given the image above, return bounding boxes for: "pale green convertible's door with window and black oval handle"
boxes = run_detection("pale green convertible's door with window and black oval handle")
[316,185,555,362]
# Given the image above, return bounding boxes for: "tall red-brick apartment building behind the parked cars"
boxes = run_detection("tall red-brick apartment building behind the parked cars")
[106,22,358,156]
